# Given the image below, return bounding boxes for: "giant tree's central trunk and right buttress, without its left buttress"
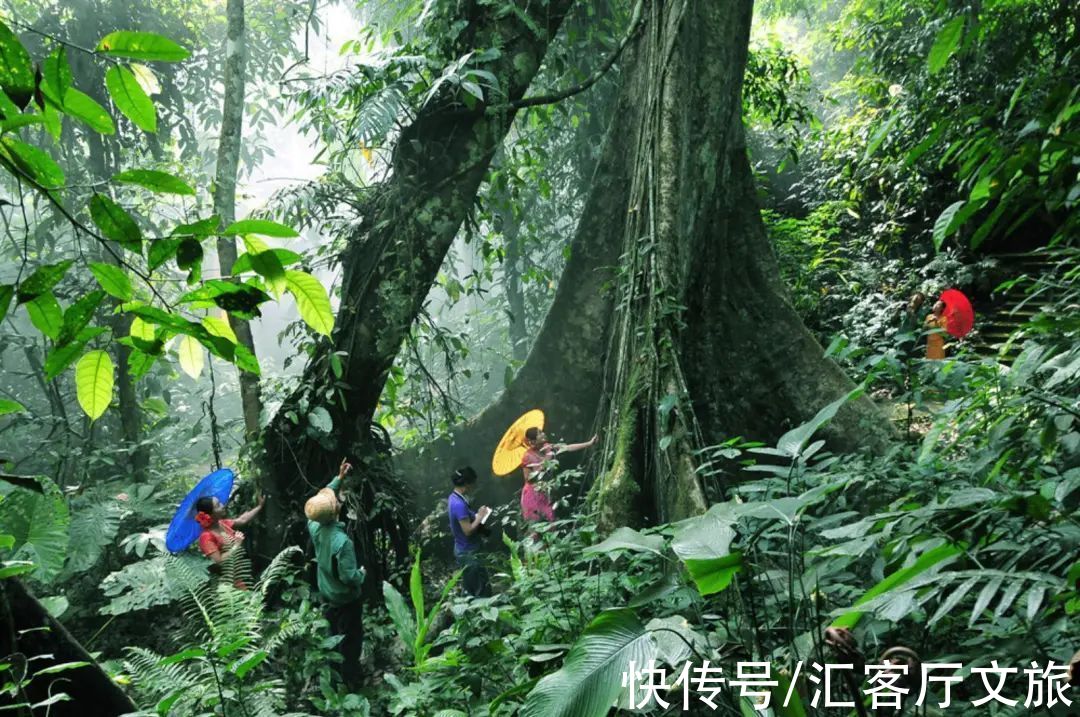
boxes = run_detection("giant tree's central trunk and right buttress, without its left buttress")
[594,0,889,527]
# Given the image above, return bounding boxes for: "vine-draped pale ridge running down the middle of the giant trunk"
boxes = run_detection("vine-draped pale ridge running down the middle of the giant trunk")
[592,0,705,528]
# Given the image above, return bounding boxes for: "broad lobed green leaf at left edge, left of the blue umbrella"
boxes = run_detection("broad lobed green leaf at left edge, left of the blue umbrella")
[0,478,69,582]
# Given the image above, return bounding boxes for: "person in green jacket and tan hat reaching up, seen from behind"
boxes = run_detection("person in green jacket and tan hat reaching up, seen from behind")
[303,459,364,687]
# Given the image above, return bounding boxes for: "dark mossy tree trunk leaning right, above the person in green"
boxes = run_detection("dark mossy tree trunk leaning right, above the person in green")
[256,0,572,561]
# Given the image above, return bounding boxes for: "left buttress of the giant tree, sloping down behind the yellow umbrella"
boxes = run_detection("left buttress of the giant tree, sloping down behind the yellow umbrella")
[399,60,643,510]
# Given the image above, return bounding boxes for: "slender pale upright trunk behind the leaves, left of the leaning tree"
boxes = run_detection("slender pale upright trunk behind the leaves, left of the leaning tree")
[214,0,262,438]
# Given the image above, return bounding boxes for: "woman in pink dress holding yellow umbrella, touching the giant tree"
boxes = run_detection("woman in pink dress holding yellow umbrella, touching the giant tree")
[491,409,597,522]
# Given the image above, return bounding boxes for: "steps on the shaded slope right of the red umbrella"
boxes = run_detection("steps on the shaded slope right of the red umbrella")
[968,247,1080,363]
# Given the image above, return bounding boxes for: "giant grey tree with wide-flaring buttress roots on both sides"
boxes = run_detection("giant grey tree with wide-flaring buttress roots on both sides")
[408,0,888,526]
